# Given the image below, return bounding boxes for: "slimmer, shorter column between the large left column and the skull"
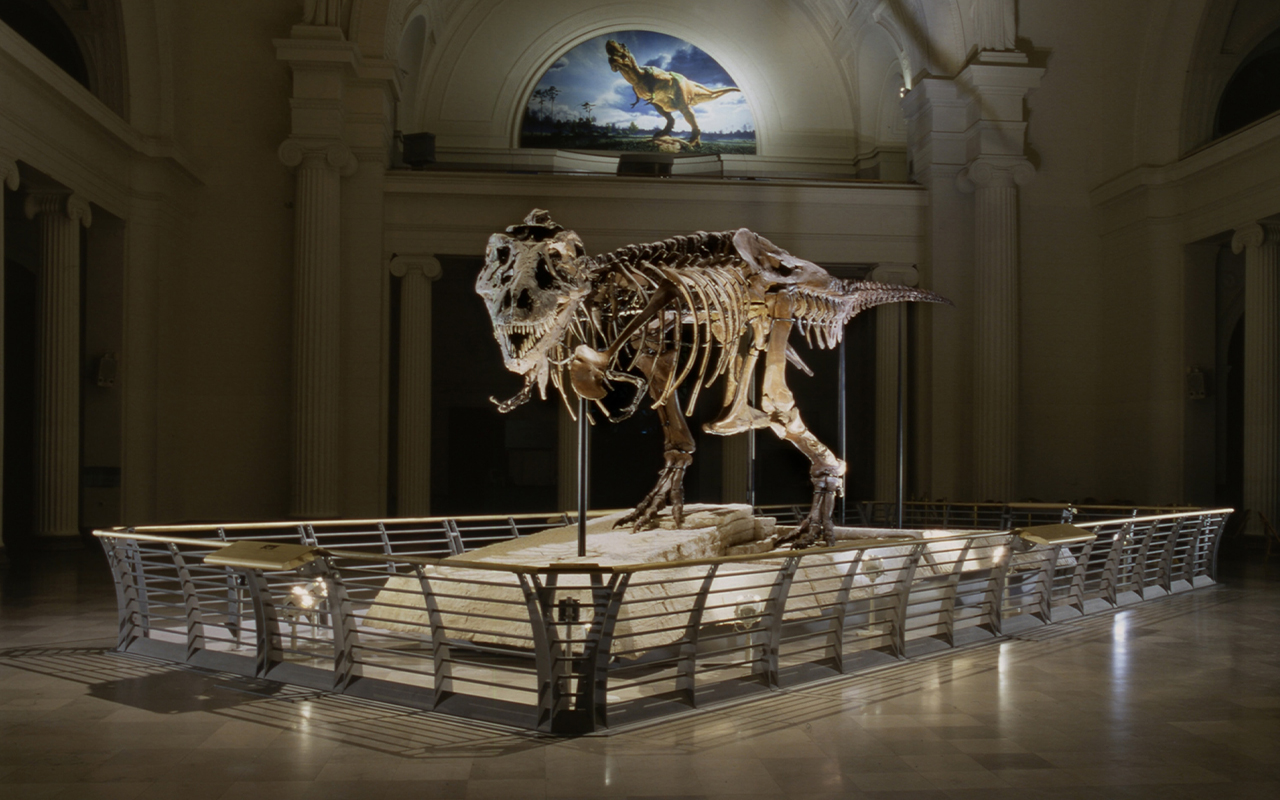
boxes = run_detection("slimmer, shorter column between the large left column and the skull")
[390,255,443,517]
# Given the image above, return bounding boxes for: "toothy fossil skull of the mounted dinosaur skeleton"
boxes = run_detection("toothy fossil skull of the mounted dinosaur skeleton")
[476,209,590,411]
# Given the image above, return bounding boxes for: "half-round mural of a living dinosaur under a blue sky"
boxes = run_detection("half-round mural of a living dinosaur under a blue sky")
[520,31,755,155]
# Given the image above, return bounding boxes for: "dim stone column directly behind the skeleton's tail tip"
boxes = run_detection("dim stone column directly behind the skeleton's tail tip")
[870,264,920,500]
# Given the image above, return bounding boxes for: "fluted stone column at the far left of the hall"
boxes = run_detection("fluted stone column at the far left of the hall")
[26,192,92,543]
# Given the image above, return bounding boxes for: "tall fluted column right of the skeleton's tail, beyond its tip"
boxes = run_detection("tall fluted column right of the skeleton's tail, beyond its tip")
[957,157,1036,500]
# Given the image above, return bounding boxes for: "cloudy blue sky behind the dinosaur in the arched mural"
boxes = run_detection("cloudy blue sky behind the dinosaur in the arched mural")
[530,31,755,134]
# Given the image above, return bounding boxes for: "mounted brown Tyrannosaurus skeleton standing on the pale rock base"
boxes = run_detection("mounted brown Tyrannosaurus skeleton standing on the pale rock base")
[476,209,950,548]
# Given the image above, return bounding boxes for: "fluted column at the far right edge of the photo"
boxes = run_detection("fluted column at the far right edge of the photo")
[1231,223,1280,534]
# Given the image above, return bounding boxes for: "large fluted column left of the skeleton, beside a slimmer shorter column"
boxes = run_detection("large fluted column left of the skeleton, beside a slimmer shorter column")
[279,138,356,518]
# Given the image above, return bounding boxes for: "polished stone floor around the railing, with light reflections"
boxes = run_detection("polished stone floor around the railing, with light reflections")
[0,540,1280,800]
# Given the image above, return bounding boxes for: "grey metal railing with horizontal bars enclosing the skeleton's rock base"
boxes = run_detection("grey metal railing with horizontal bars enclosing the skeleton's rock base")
[95,508,1230,733]
